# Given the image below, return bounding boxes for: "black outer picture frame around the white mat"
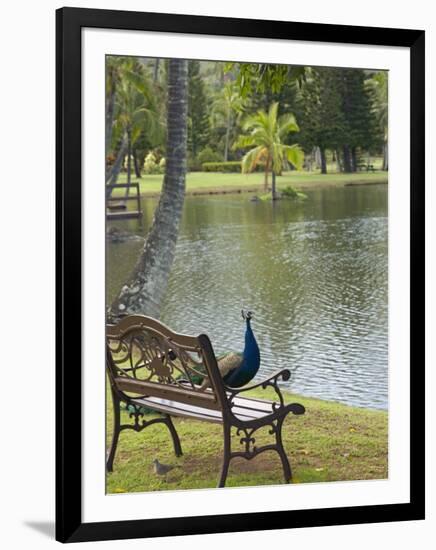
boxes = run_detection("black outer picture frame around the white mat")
[56,8,425,542]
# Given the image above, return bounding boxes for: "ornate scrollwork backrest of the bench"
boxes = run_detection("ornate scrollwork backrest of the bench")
[106,315,228,410]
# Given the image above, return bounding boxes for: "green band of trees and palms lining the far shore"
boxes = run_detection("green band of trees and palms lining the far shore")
[106,56,388,194]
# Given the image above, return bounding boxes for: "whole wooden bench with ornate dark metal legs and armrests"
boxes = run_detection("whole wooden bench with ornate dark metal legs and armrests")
[106,315,305,487]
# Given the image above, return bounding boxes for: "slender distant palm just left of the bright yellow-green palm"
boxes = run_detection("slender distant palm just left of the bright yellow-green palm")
[212,81,244,162]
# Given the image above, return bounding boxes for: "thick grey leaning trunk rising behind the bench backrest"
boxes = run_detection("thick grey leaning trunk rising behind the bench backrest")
[110,59,188,319]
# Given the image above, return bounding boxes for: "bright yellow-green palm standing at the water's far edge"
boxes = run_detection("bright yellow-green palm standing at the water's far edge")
[234,103,304,200]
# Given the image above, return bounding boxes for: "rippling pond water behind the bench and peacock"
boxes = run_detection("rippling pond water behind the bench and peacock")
[106,185,388,409]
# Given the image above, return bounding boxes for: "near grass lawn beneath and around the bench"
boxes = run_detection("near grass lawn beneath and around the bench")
[107,390,388,493]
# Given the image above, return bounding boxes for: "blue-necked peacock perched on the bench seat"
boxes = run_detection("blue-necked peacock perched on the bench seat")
[201,310,260,389]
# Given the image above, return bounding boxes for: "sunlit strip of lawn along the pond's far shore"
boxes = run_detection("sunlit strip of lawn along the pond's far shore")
[114,170,388,201]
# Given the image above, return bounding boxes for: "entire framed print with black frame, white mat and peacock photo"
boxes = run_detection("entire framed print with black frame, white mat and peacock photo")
[56,8,424,542]
